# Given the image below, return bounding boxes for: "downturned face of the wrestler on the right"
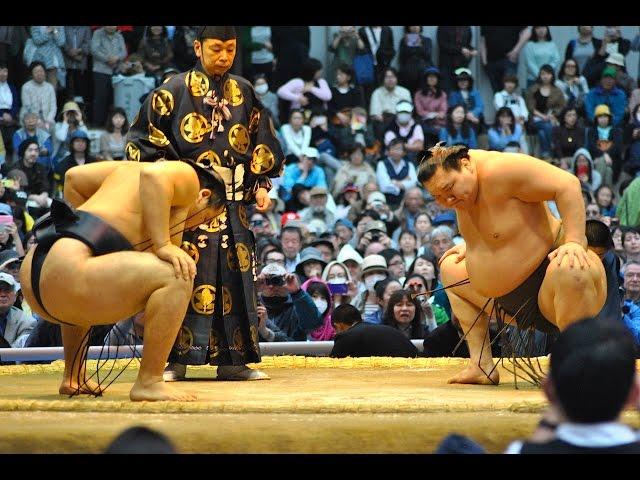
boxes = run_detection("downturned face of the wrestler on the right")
[424,158,478,209]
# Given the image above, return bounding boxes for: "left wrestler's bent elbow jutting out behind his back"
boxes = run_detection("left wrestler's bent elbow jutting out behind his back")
[64,161,129,208]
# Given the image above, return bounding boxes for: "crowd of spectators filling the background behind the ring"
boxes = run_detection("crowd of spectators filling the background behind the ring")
[0,26,640,362]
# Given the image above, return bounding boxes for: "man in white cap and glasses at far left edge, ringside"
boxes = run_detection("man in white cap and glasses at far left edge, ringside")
[0,272,36,348]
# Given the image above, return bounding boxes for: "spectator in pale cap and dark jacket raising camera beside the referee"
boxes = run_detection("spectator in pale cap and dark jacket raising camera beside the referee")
[257,263,322,342]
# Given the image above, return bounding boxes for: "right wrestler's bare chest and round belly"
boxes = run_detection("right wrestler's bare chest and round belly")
[454,150,562,297]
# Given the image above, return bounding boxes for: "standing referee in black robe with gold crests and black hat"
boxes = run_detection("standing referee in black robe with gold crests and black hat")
[125,25,284,381]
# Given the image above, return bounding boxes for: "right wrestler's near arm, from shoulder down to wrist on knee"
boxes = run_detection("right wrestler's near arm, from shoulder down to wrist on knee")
[491,153,587,249]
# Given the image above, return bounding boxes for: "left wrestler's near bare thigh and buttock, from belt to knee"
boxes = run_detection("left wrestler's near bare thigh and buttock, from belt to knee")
[40,239,192,325]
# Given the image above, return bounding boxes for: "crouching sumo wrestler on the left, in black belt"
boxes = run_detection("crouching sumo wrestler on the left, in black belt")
[20,160,225,401]
